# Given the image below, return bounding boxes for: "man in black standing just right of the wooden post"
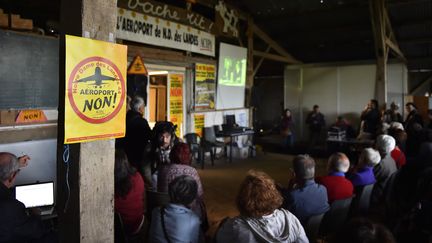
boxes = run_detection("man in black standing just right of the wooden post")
[125,96,151,186]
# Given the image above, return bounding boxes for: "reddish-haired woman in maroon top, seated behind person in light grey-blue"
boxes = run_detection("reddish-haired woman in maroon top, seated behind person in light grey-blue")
[157,143,208,231]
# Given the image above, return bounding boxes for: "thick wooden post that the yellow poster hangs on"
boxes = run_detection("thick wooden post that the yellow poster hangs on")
[57,0,117,242]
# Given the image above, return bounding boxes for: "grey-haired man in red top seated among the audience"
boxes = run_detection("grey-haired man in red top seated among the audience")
[317,153,354,203]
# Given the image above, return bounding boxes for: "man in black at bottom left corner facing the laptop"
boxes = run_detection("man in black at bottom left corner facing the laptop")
[0,152,56,242]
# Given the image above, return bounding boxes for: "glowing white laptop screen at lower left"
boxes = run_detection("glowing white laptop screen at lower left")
[15,182,54,208]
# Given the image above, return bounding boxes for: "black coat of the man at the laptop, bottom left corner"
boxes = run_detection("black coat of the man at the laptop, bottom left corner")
[0,182,47,242]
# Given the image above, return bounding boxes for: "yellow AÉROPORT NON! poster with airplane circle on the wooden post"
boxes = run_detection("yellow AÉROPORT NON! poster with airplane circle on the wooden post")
[64,35,127,143]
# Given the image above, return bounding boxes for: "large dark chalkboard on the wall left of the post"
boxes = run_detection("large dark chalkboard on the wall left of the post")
[0,30,59,109]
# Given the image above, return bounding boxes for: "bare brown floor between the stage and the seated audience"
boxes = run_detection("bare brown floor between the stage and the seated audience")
[197,152,326,237]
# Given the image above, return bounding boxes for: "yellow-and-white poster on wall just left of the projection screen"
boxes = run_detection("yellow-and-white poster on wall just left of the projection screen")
[194,63,216,111]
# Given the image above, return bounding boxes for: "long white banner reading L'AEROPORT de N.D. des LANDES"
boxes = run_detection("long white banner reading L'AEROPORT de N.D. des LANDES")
[116,8,215,57]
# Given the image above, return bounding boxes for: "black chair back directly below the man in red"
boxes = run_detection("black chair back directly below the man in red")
[321,197,353,235]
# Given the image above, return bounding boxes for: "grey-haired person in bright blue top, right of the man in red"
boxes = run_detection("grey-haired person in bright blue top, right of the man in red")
[347,148,381,187]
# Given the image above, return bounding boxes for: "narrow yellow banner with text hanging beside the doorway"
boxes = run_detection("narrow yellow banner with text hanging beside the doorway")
[169,74,183,137]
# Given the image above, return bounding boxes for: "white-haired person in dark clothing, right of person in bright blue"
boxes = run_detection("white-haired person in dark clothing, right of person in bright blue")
[371,135,397,204]
